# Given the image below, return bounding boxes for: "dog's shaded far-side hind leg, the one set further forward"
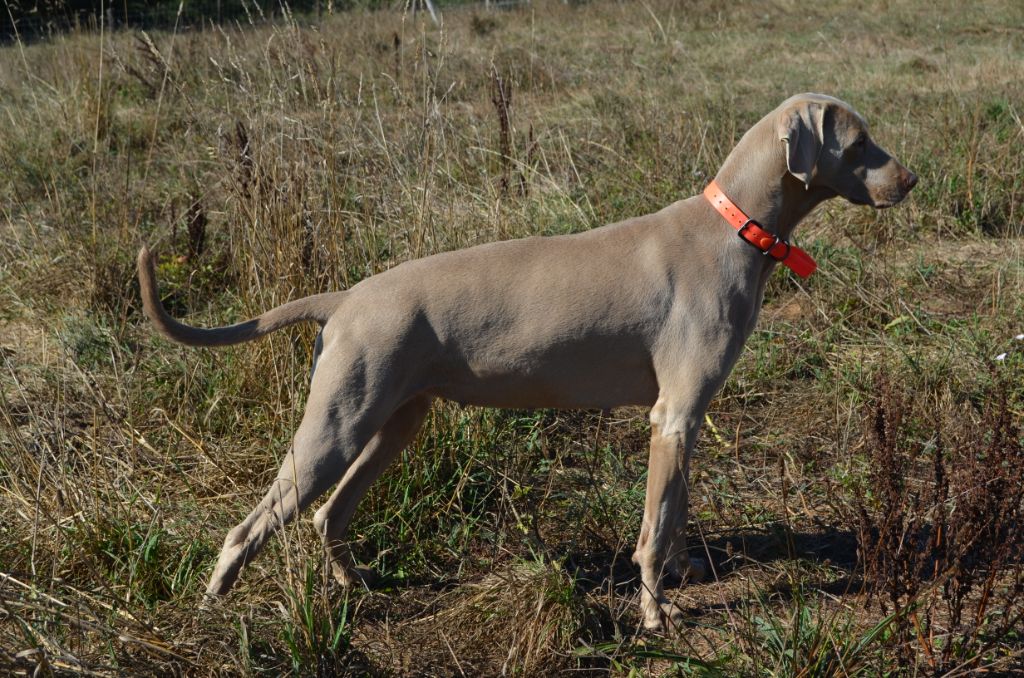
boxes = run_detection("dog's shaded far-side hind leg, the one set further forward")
[313,395,431,586]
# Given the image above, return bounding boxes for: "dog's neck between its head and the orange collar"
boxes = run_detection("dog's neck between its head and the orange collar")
[715,117,835,240]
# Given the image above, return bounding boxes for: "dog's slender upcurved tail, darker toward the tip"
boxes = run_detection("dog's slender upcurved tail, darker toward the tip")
[138,247,345,346]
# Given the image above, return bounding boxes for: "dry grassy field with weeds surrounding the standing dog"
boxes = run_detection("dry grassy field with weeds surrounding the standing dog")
[0,0,1024,676]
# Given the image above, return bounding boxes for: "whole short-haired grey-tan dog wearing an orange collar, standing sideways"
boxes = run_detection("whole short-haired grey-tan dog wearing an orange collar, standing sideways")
[138,94,918,630]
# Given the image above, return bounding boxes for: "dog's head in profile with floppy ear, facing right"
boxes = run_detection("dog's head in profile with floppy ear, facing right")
[776,94,918,208]
